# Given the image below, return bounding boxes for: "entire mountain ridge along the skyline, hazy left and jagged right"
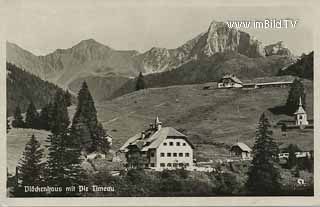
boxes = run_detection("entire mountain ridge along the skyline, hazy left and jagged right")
[7,21,291,88]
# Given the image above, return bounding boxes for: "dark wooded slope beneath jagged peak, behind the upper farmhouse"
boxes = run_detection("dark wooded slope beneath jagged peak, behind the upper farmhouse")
[106,52,293,100]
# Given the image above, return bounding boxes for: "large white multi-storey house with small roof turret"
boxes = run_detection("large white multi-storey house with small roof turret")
[120,117,194,171]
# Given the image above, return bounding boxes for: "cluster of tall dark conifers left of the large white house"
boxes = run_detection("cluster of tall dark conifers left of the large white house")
[12,82,110,197]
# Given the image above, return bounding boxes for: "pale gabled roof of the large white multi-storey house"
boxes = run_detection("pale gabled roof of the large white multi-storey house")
[120,127,194,151]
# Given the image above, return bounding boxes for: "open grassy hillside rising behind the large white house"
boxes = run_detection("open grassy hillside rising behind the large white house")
[92,80,313,159]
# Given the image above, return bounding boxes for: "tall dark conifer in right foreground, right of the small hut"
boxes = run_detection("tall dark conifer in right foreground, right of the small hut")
[246,114,280,195]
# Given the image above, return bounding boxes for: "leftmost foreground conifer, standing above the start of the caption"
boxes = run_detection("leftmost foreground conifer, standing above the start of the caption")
[15,135,44,196]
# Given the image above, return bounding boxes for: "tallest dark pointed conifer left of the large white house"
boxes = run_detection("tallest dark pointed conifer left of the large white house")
[72,82,103,152]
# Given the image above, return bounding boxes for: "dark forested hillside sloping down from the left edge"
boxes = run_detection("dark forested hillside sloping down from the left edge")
[7,63,72,115]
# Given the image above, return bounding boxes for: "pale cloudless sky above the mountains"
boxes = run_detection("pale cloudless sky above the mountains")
[4,0,316,55]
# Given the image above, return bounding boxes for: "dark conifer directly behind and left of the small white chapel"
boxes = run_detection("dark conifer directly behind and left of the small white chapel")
[286,79,306,114]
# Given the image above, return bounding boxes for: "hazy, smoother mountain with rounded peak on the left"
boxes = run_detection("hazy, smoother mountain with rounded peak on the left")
[7,39,139,87]
